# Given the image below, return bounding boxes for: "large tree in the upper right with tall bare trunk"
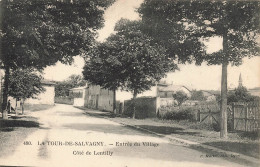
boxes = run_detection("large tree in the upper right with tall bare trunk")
[139,0,260,138]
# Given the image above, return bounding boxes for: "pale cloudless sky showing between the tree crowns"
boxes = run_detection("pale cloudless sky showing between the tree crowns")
[44,0,260,90]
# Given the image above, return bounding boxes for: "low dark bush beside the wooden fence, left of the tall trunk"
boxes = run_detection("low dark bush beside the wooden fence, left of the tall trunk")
[161,108,195,121]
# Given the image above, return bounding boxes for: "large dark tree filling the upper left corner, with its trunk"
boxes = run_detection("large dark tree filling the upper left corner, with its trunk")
[0,0,113,118]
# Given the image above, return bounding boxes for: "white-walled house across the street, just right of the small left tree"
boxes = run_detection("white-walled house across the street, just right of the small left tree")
[25,80,55,105]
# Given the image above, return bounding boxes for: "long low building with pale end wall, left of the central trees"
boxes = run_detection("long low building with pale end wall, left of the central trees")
[70,84,114,112]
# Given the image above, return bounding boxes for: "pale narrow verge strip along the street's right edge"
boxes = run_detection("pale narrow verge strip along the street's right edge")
[80,108,259,167]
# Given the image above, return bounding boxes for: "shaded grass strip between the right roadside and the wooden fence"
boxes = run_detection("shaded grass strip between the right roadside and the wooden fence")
[106,117,260,158]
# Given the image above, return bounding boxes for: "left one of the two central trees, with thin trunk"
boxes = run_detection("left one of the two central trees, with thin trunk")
[83,40,124,112]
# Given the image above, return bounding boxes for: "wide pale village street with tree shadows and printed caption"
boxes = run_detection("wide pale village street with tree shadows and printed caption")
[0,104,246,167]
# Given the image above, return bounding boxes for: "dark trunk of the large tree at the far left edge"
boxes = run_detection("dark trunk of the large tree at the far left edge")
[2,65,10,119]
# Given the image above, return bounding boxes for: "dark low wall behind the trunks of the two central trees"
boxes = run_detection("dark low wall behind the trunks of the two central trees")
[123,97,157,119]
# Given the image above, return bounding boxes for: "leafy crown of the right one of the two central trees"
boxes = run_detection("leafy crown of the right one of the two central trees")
[109,19,177,95]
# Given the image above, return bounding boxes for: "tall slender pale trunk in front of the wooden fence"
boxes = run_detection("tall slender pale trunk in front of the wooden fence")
[220,33,228,138]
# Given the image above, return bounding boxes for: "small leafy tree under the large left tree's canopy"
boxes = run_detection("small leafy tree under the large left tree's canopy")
[8,69,45,114]
